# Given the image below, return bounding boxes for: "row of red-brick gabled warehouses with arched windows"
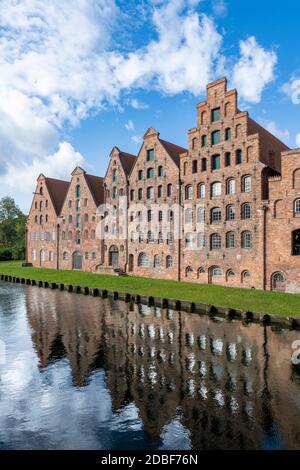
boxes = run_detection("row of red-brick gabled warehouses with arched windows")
[27,79,300,292]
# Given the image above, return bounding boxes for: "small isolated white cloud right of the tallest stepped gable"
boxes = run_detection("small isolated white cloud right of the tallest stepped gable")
[232,36,277,103]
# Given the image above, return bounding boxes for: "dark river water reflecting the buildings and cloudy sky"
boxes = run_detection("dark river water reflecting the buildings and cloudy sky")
[0,282,300,449]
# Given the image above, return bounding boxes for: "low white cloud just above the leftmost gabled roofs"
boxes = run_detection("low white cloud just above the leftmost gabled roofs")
[2,142,84,192]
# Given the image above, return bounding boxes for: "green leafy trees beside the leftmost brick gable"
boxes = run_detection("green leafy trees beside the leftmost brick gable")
[0,197,26,259]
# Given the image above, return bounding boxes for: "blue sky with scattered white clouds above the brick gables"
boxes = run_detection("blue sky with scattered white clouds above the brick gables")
[0,0,300,211]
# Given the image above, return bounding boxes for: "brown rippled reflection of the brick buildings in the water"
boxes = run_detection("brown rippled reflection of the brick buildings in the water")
[26,288,300,449]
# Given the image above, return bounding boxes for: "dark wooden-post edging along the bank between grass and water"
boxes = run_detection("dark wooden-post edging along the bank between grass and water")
[0,273,300,329]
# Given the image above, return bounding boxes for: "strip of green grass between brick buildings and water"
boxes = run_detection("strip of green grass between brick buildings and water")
[0,261,300,317]
